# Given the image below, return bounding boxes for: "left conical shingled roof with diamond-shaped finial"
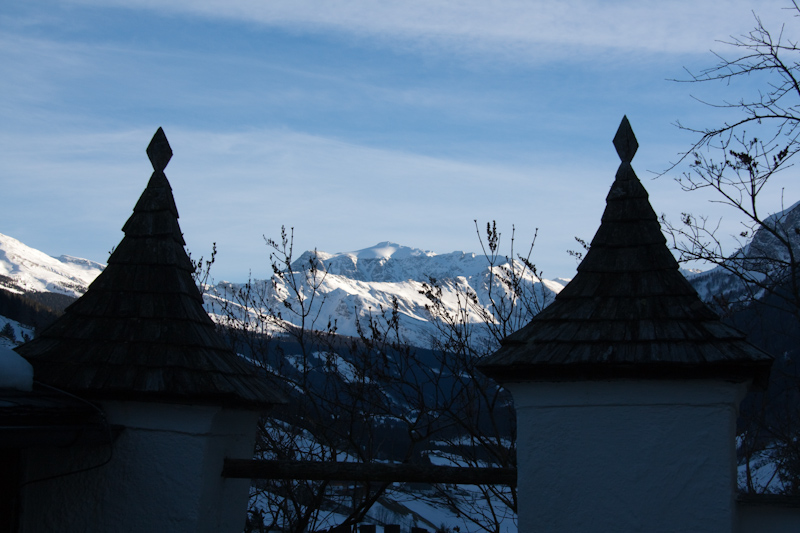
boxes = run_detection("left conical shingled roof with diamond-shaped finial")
[17,128,284,408]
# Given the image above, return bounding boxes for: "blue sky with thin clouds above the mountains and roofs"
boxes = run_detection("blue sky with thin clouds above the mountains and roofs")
[0,0,800,281]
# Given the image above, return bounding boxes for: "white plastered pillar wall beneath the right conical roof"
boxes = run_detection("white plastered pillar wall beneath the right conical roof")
[506,381,746,533]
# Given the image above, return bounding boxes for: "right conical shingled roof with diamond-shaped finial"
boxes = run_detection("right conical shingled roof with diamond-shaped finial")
[478,117,772,386]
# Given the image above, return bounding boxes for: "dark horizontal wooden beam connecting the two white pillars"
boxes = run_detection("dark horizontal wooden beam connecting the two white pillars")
[222,458,517,486]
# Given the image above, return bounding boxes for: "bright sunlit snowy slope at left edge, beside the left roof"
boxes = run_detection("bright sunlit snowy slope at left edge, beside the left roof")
[0,233,105,297]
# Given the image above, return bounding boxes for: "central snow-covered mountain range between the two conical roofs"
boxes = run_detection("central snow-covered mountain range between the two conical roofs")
[207,242,568,347]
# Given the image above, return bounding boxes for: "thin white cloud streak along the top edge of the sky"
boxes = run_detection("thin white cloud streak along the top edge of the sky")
[70,0,785,63]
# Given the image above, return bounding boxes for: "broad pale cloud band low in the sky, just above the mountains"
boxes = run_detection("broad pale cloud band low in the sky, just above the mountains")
[6,120,780,280]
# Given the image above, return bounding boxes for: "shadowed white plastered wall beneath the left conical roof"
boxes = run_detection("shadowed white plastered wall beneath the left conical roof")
[21,402,258,533]
